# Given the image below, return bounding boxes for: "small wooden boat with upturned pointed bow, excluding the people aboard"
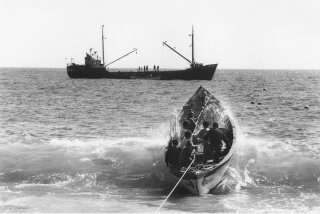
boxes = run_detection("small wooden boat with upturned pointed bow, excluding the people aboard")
[168,86,236,195]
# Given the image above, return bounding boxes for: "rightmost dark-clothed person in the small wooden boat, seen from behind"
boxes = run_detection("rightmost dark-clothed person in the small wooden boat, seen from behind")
[204,122,230,163]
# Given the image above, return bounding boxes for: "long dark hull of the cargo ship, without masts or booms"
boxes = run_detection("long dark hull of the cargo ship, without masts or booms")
[67,64,217,80]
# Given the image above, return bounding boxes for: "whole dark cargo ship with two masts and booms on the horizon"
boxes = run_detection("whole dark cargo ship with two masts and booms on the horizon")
[67,25,218,80]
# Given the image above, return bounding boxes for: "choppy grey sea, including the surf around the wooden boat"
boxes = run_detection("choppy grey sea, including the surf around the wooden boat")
[0,68,320,213]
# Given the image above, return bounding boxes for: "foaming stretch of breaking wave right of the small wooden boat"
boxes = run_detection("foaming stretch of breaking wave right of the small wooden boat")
[218,128,320,194]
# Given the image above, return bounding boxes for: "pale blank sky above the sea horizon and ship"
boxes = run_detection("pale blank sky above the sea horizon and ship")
[0,0,320,69]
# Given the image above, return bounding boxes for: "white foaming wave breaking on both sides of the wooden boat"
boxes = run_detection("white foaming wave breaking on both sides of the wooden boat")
[0,122,320,197]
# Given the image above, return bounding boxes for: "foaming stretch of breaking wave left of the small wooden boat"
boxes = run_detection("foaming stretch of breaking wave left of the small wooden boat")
[0,125,174,194]
